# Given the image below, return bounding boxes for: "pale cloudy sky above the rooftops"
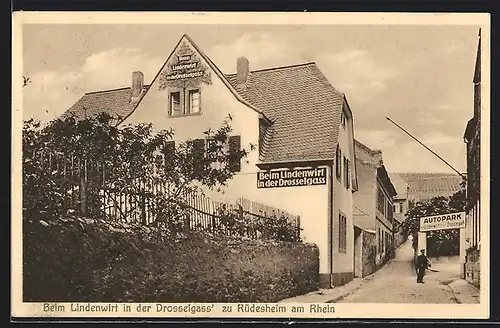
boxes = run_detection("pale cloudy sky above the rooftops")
[22,24,479,173]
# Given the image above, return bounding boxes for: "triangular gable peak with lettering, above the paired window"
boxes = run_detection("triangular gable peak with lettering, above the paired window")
[160,40,212,90]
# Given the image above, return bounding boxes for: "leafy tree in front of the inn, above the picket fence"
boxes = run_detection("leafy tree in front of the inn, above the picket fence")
[23,113,253,231]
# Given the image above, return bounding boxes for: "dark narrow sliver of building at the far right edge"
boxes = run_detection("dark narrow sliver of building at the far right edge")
[464,30,481,287]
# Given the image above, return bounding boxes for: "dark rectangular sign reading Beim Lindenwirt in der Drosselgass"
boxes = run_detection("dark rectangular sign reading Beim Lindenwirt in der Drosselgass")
[257,167,326,188]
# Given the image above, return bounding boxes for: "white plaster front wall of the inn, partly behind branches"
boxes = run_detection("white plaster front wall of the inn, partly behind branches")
[122,43,332,273]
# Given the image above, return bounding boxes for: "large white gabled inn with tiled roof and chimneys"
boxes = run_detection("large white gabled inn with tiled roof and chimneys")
[60,35,358,287]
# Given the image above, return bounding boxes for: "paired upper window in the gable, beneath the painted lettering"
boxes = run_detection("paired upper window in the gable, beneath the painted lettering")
[168,88,201,116]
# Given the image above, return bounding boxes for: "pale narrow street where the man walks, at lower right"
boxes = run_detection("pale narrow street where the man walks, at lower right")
[338,240,474,304]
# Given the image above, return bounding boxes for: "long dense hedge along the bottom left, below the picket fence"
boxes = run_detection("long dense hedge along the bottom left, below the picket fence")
[23,218,319,302]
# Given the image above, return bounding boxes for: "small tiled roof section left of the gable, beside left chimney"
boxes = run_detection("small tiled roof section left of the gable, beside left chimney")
[60,86,149,125]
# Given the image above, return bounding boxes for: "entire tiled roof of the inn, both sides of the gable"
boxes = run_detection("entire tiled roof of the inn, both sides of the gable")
[62,35,348,170]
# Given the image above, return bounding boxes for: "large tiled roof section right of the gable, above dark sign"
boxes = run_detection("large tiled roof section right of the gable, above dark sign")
[226,63,344,162]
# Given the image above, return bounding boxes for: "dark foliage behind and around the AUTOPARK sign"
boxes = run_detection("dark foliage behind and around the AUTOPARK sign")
[402,189,465,256]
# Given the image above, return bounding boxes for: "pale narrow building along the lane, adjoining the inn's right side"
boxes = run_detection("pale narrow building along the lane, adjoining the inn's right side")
[354,140,397,277]
